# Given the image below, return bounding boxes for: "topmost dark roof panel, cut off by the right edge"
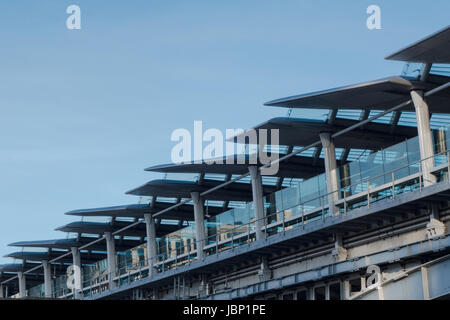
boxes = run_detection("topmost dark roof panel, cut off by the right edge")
[386,26,450,63]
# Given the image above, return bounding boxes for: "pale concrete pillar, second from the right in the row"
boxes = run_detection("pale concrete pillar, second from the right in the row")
[319,132,339,215]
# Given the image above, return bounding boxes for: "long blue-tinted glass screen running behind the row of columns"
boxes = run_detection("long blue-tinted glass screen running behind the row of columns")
[51,124,450,296]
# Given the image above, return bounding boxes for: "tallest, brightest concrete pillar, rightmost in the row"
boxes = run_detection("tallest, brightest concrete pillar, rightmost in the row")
[411,90,436,187]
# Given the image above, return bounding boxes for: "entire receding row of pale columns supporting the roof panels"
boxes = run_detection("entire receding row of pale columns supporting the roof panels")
[11,86,436,299]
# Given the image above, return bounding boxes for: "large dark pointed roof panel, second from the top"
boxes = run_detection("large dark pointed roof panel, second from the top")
[264,76,450,113]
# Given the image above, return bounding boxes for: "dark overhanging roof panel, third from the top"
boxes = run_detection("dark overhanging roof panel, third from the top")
[232,117,417,150]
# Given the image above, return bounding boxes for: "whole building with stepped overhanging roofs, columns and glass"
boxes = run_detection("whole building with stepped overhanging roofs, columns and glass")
[0,27,450,300]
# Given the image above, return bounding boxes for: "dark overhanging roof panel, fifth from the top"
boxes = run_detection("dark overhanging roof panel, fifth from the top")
[127,179,275,201]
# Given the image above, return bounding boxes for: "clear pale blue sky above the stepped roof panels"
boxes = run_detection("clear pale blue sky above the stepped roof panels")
[0,0,450,263]
